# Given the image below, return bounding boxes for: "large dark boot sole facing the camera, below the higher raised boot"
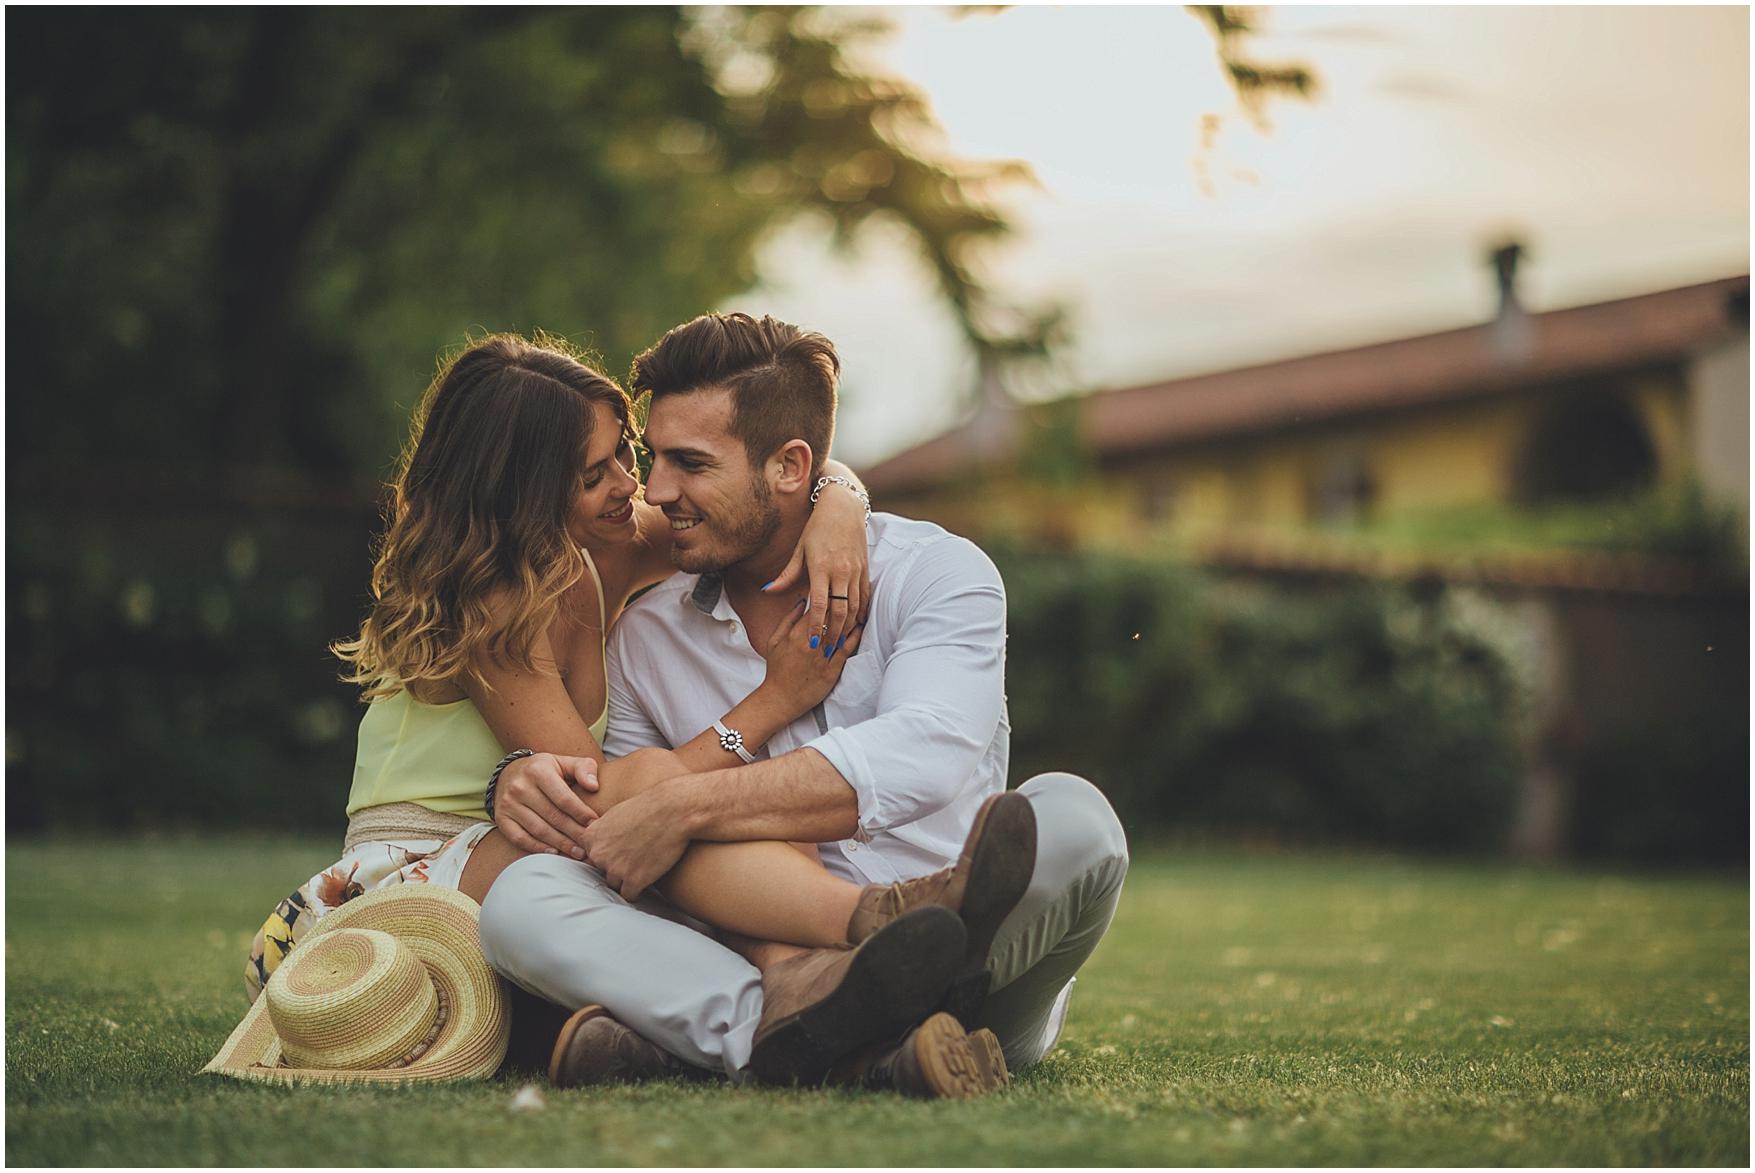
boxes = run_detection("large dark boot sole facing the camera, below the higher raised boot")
[749,906,969,1083]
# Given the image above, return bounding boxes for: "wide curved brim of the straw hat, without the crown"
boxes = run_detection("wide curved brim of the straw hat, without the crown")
[202,883,511,1083]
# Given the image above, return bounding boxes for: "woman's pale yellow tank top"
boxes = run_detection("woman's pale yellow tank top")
[347,553,609,818]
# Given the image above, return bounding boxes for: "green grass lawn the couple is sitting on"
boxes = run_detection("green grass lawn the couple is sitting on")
[5,839,1750,1166]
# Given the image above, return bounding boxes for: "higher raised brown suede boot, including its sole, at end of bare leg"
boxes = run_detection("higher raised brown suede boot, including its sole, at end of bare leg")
[848,790,1035,1025]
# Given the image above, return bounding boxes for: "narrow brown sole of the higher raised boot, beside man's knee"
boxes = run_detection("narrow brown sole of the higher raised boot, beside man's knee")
[944,790,1035,1029]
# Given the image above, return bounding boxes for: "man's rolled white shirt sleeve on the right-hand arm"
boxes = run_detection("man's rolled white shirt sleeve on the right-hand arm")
[809,537,1006,839]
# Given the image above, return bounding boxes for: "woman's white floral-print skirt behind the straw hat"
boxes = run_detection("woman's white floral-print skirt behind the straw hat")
[244,822,493,1001]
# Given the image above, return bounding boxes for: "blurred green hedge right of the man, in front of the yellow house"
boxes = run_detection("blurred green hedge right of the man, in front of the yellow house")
[997,550,1520,850]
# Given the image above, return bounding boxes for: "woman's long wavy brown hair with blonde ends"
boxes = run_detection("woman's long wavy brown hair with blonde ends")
[330,334,630,701]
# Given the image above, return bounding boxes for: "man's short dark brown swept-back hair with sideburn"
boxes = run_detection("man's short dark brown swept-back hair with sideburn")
[630,314,841,479]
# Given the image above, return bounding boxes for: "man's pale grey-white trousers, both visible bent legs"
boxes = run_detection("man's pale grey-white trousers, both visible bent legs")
[481,774,1127,1078]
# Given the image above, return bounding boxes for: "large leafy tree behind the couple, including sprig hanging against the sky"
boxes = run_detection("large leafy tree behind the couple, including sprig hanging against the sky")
[7,7,1312,484]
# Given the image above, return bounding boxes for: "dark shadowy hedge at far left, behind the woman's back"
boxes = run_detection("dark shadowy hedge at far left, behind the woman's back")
[7,516,367,831]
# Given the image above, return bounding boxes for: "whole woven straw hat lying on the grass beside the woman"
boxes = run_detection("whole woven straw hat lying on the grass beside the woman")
[202,883,511,1083]
